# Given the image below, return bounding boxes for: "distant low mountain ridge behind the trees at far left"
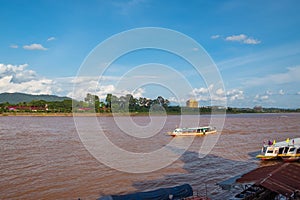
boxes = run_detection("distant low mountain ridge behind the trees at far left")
[0,93,71,104]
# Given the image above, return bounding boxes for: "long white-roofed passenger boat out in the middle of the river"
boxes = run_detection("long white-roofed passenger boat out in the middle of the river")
[168,126,217,136]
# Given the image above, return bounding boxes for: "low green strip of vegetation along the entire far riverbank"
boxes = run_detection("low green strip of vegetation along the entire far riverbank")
[0,93,300,115]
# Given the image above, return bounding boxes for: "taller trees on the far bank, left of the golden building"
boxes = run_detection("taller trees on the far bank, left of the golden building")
[0,93,180,113]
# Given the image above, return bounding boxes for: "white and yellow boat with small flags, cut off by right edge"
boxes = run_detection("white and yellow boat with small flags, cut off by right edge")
[256,138,300,160]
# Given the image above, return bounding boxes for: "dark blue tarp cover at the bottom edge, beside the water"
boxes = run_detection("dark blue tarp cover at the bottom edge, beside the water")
[98,184,193,200]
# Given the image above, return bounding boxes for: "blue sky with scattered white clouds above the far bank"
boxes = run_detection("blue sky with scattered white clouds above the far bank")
[0,0,300,108]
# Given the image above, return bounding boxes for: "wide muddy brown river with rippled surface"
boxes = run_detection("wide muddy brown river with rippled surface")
[0,114,300,200]
